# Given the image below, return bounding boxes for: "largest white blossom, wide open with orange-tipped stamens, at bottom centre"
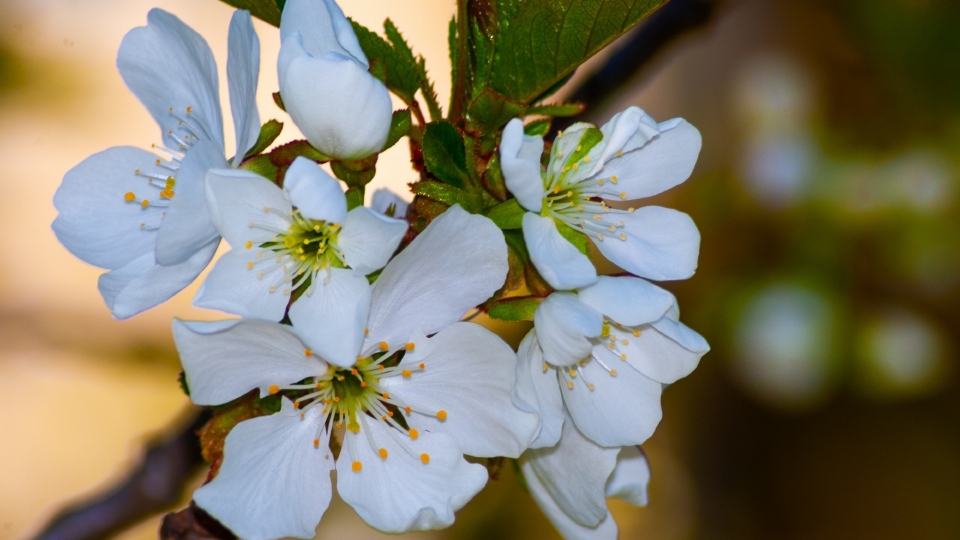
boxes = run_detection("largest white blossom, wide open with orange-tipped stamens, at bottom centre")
[174,206,538,540]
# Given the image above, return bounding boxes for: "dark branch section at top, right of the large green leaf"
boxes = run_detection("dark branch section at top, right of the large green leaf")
[547,0,723,136]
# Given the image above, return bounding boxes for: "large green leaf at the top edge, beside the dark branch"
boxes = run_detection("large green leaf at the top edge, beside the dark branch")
[490,0,666,103]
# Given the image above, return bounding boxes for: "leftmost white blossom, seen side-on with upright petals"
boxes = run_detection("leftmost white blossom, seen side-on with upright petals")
[53,9,260,319]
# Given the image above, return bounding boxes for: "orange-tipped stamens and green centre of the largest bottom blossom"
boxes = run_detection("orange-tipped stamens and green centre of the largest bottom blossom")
[269,342,447,472]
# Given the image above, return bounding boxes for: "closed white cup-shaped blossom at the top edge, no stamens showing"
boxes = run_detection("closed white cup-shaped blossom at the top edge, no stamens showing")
[277,0,393,159]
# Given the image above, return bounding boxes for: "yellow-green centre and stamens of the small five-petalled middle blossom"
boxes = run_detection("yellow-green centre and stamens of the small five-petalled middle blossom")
[244,207,347,296]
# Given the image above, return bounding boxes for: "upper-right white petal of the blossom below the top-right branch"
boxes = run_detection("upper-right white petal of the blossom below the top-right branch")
[597,118,700,199]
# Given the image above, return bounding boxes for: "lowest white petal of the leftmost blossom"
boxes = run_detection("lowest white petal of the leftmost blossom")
[97,240,220,319]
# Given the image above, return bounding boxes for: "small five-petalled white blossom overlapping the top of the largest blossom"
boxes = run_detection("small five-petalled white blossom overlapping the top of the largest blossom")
[194,157,407,367]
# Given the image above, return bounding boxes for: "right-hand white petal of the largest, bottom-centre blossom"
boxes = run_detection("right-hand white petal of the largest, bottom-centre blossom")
[380,322,539,458]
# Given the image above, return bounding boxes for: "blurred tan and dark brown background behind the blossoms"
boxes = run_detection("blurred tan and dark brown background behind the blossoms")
[0,0,960,540]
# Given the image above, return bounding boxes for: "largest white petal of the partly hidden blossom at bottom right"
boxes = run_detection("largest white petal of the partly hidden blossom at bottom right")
[520,414,619,527]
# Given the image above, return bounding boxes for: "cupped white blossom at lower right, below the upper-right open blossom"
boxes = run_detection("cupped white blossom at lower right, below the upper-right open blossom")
[517,276,710,448]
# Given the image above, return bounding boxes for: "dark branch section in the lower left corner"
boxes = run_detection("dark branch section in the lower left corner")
[34,410,210,540]
